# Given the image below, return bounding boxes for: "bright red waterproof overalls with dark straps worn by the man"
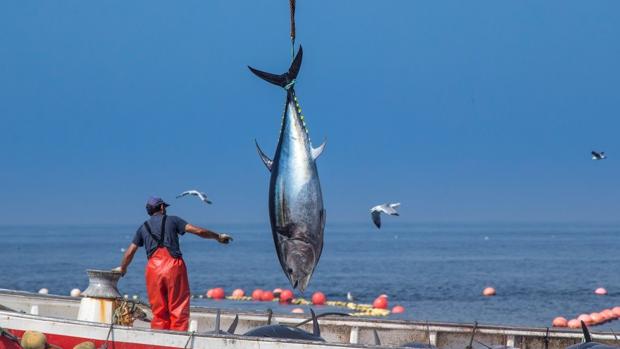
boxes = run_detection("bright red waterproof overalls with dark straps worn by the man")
[144,216,190,331]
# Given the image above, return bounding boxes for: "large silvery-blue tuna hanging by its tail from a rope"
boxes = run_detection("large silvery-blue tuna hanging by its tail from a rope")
[249,47,325,292]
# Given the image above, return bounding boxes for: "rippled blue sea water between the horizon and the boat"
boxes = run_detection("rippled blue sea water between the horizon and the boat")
[0,222,620,329]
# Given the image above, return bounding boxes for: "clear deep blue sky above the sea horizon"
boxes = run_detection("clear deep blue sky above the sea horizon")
[0,0,620,224]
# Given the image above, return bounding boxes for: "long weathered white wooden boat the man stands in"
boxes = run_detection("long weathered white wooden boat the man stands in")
[0,290,618,349]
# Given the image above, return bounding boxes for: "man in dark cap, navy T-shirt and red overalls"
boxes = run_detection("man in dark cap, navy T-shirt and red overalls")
[117,197,232,331]
